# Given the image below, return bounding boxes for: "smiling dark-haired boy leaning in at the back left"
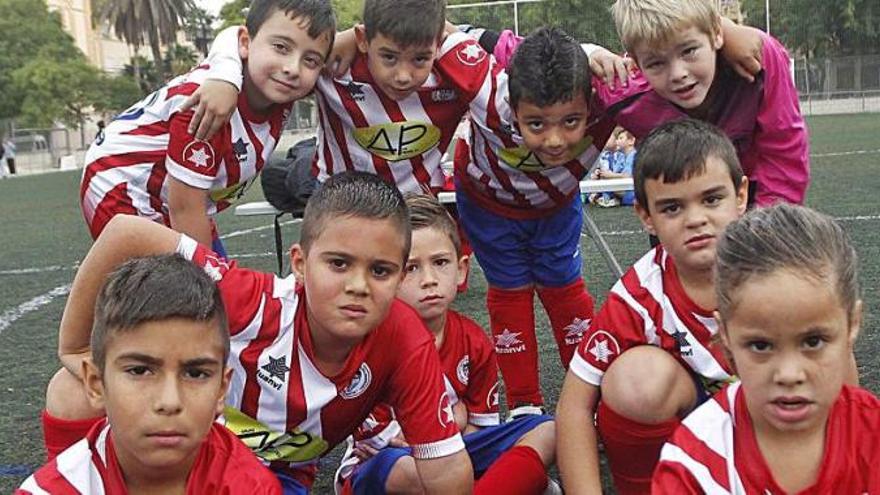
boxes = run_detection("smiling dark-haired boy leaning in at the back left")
[80,0,335,256]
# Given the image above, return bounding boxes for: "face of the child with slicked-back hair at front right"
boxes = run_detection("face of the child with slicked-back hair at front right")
[716,270,861,433]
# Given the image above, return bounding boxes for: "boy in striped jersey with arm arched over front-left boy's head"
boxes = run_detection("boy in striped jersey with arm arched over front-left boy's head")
[48,173,473,493]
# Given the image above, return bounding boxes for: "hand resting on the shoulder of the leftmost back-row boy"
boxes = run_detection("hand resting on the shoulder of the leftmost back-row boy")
[180,79,238,141]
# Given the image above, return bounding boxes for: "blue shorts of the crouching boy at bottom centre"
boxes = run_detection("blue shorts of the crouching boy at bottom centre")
[351,415,553,495]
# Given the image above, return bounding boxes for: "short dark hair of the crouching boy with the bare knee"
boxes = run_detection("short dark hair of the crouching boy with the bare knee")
[633,118,743,211]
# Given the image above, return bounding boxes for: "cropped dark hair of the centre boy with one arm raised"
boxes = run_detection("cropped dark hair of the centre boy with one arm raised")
[299,171,412,261]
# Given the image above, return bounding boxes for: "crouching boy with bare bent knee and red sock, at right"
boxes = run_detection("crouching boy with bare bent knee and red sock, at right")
[557,119,748,494]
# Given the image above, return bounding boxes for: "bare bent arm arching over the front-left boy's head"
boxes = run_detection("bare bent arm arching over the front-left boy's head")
[58,215,180,379]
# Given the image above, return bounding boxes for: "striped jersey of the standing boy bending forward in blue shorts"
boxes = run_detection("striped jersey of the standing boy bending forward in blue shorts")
[455,70,614,219]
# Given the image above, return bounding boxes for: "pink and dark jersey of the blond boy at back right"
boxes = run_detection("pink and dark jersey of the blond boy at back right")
[493,31,810,206]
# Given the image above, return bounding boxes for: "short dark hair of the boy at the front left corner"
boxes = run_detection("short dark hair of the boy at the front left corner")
[90,254,229,372]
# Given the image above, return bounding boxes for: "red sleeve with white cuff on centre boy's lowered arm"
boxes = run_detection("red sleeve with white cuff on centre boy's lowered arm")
[387,312,464,459]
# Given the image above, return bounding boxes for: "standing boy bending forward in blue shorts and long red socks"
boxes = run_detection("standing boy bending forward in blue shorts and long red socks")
[455,28,614,416]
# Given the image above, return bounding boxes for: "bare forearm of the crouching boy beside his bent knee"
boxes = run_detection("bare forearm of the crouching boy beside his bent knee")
[556,370,602,495]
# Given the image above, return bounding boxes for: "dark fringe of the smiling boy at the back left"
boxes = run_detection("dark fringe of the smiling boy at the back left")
[245,0,336,47]
